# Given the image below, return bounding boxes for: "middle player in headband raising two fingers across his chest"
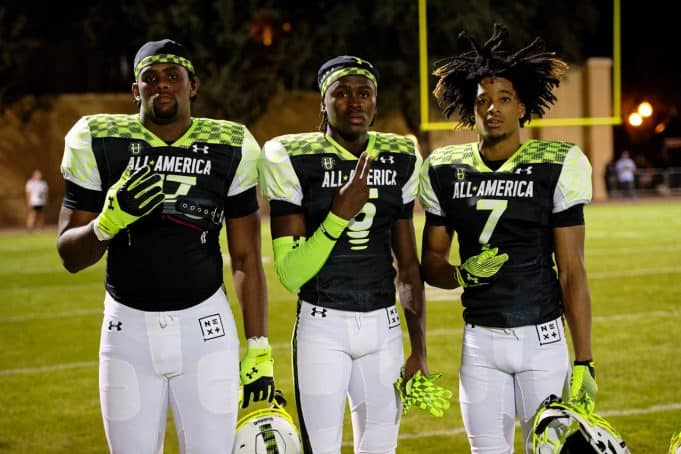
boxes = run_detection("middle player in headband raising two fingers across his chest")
[261,55,451,454]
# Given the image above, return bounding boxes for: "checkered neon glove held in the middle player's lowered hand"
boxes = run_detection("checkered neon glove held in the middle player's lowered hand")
[395,369,452,417]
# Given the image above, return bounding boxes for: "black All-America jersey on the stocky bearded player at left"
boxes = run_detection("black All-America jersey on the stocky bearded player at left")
[62,114,260,311]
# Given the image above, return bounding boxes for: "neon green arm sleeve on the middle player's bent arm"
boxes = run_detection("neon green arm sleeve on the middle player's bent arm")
[272,212,350,292]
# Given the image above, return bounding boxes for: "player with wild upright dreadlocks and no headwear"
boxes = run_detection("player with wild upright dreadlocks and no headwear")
[420,25,597,453]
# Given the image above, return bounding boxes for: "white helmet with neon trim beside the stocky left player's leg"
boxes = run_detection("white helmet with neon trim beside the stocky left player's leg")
[232,390,302,454]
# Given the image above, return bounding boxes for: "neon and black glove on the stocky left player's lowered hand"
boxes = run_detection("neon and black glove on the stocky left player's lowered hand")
[239,345,274,408]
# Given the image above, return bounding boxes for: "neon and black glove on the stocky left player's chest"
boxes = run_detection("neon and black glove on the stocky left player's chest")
[94,165,165,241]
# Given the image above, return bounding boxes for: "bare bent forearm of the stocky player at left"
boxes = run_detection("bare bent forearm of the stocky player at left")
[57,221,109,273]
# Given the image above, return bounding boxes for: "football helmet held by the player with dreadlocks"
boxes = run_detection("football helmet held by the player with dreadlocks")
[531,394,630,454]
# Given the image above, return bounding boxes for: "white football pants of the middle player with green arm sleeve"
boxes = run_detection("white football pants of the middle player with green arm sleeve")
[293,302,404,454]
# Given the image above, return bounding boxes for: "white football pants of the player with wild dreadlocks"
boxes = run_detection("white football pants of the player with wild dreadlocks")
[459,318,570,454]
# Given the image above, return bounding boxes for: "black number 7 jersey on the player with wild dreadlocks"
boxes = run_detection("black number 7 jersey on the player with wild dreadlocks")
[419,140,591,327]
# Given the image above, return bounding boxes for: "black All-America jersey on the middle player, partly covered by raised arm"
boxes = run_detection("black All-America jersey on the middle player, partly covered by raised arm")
[261,132,421,312]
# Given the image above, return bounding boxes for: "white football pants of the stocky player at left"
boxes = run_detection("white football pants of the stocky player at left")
[99,289,239,454]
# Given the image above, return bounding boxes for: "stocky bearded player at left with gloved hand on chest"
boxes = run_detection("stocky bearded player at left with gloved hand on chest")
[57,39,274,454]
